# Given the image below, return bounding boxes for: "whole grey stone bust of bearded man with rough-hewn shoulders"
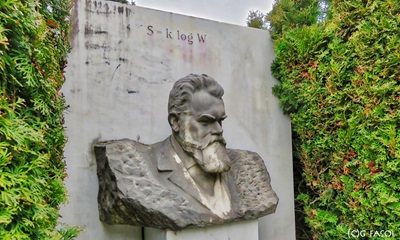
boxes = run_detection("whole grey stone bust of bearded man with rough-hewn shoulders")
[95,74,278,230]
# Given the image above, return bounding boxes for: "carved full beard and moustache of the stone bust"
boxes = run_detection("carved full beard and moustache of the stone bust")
[181,129,231,173]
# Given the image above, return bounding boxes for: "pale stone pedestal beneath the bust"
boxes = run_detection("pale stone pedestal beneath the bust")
[144,220,259,240]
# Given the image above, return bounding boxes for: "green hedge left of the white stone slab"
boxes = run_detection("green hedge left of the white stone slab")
[0,0,78,239]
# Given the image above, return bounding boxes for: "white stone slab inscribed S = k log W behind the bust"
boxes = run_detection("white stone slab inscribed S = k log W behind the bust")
[61,0,295,240]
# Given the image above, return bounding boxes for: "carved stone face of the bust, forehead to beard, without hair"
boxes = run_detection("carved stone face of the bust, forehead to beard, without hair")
[177,91,230,173]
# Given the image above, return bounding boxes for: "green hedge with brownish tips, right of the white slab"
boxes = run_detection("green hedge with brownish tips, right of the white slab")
[269,0,400,239]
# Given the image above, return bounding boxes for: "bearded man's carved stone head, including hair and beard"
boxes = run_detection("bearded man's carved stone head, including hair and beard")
[168,74,230,173]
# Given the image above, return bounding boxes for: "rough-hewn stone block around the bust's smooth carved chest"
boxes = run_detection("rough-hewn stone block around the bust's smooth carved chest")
[95,139,278,230]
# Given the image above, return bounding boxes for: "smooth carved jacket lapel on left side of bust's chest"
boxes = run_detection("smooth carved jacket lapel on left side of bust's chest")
[157,138,205,206]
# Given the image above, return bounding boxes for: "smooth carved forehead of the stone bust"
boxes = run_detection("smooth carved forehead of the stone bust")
[191,91,225,118]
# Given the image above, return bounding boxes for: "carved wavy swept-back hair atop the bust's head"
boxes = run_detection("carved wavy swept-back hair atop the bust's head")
[168,74,224,115]
